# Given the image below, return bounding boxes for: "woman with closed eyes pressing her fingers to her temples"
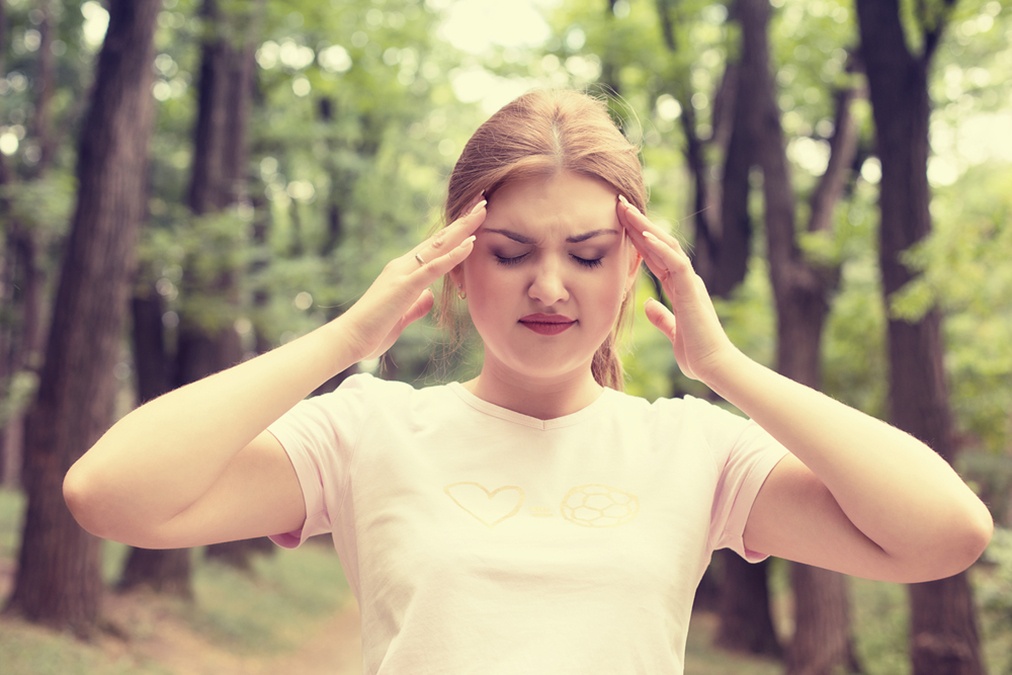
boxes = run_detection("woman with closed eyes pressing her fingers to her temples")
[65,92,992,673]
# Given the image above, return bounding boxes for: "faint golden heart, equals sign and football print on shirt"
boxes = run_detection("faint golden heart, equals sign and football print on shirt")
[443,482,640,527]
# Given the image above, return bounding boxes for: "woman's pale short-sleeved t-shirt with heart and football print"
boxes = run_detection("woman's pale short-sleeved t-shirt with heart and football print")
[270,375,786,675]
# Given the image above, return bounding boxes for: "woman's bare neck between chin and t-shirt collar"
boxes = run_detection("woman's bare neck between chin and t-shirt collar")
[465,362,603,420]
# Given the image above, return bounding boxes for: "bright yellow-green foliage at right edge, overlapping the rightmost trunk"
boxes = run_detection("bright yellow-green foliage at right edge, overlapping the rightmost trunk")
[892,166,1012,453]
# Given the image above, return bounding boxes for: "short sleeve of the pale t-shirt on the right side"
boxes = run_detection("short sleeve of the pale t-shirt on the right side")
[696,401,787,563]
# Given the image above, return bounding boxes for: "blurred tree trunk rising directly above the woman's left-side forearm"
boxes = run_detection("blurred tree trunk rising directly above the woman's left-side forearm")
[175,0,270,568]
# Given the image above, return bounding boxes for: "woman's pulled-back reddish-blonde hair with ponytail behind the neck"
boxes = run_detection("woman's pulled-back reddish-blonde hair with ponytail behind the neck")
[440,90,647,390]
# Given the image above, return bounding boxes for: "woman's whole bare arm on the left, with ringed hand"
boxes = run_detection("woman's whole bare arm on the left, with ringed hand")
[64,202,485,549]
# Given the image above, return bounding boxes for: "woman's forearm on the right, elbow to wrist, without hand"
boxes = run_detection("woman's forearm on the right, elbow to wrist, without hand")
[707,353,991,557]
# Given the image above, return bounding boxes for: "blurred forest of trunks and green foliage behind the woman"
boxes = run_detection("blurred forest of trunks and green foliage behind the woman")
[0,0,1012,675]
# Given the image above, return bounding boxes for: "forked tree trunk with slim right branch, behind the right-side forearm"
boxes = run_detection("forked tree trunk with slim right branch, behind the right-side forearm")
[735,0,857,675]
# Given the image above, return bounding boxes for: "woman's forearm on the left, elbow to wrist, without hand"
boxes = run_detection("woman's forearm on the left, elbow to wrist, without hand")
[65,319,355,534]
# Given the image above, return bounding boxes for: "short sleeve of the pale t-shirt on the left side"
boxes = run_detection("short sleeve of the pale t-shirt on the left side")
[267,374,377,549]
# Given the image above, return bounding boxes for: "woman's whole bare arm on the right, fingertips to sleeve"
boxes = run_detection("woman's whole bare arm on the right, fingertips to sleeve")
[618,198,993,582]
